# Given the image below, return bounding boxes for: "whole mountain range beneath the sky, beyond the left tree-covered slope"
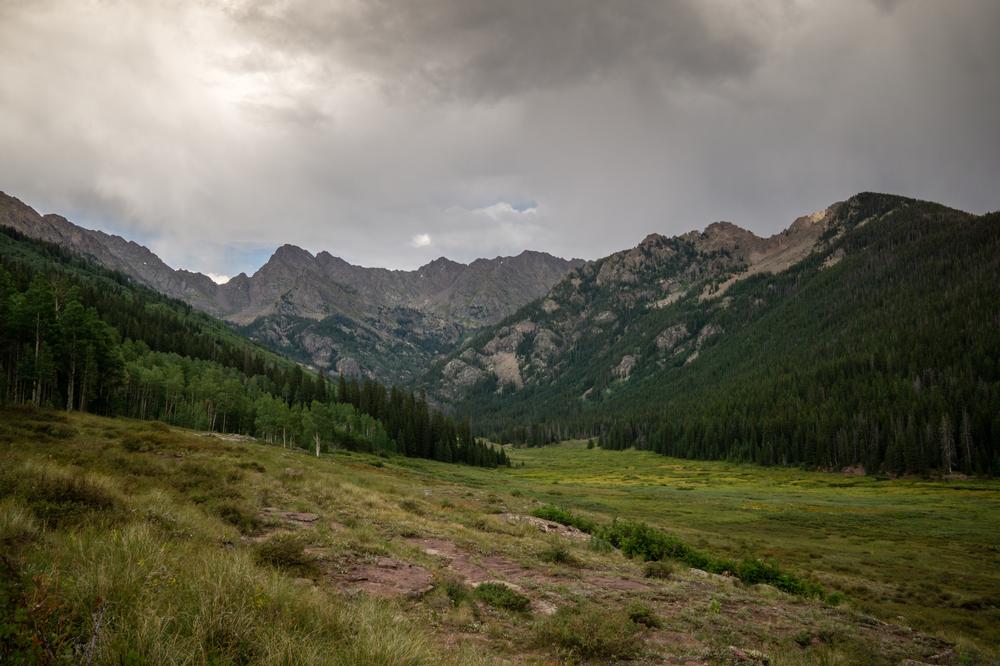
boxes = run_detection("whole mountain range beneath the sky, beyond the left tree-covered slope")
[0,192,1000,473]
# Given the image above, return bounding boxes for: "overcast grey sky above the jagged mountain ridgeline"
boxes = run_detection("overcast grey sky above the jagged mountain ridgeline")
[0,0,1000,279]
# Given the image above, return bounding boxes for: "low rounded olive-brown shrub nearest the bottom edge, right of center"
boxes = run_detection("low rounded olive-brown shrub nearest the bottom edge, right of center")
[534,603,642,661]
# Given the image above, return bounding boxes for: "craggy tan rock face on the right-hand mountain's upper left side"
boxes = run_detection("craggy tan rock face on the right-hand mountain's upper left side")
[427,192,892,400]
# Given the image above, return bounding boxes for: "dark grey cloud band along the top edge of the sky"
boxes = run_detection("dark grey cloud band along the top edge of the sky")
[232,0,763,100]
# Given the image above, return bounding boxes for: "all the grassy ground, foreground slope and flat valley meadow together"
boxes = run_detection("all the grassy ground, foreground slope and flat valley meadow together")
[0,410,998,666]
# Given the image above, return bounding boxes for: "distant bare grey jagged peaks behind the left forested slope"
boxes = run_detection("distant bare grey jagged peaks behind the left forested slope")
[0,193,583,382]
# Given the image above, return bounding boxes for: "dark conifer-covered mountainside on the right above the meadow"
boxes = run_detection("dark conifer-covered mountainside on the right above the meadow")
[438,194,1000,474]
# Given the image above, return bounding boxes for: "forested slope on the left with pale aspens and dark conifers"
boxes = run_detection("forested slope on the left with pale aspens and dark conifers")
[0,228,507,466]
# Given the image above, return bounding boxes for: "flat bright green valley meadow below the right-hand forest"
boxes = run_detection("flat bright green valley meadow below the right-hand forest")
[402,441,1000,654]
